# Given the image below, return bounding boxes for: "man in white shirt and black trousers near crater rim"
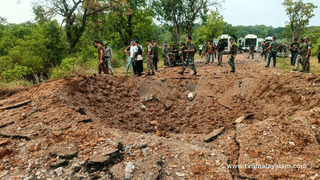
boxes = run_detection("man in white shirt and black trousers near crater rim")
[133,40,144,76]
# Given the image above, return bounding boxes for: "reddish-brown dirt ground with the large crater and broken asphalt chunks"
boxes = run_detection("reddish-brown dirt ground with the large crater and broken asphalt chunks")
[0,55,320,179]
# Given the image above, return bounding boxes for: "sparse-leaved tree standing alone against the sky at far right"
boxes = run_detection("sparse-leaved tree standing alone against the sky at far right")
[282,0,317,40]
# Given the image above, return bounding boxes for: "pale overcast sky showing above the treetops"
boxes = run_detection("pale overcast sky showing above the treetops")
[0,0,320,27]
